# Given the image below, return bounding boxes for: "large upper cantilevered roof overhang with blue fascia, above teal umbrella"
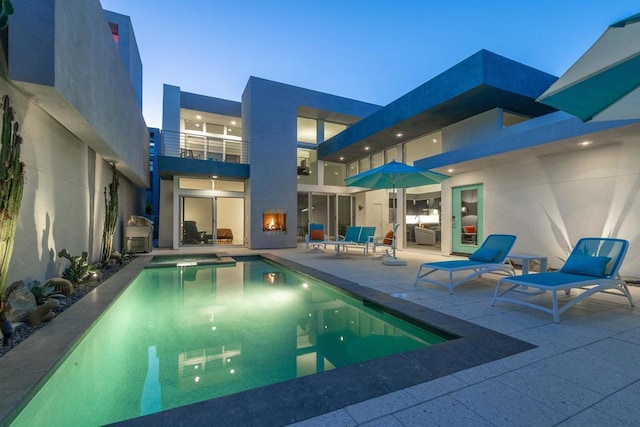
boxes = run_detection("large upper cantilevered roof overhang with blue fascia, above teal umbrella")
[318,50,557,162]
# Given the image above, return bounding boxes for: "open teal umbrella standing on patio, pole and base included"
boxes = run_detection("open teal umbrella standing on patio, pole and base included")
[345,160,449,265]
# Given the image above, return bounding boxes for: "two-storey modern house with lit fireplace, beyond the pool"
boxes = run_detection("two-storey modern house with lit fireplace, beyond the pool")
[157,51,640,277]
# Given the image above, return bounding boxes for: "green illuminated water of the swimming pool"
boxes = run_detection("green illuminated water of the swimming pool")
[12,259,447,426]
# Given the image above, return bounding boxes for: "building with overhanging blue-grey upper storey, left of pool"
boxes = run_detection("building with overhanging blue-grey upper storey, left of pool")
[0,0,149,284]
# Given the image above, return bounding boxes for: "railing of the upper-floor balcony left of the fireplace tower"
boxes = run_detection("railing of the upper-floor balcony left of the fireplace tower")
[162,130,249,164]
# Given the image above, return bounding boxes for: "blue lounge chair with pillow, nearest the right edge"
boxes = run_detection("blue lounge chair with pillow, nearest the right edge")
[491,237,634,323]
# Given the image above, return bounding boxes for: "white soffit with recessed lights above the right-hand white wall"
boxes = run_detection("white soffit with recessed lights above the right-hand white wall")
[431,119,640,175]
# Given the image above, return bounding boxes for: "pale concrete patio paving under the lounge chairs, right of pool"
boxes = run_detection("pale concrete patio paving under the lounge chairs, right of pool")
[262,248,640,426]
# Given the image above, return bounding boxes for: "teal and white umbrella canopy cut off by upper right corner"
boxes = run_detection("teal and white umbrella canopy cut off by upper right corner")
[537,13,640,122]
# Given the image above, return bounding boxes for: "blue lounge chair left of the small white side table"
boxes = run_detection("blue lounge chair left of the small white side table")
[415,234,516,295]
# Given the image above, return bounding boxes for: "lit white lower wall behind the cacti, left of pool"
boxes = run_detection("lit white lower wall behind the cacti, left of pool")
[0,80,137,284]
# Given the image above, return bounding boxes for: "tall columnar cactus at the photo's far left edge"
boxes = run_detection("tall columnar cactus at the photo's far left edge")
[0,95,24,342]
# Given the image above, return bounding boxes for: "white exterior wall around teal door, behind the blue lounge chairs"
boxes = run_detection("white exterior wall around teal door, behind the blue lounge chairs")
[442,143,640,278]
